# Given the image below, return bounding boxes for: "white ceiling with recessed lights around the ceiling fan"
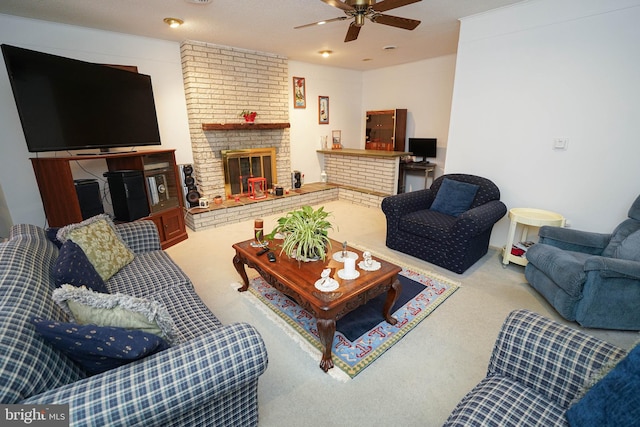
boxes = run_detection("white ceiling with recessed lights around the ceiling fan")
[0,0,522,70]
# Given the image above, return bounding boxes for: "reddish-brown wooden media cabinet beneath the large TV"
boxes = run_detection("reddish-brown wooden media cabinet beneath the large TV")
[31,150,187,249]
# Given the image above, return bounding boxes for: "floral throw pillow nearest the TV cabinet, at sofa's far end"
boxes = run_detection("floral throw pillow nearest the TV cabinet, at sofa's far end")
[57,214,134,282]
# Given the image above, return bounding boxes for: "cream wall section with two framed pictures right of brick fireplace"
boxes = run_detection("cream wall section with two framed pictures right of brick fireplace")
[289,61,364,186]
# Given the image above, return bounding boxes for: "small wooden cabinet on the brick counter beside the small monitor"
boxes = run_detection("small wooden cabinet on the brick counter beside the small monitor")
[365,108,407,151]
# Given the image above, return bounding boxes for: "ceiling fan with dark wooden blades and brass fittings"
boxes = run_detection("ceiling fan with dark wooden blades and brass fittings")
[295,0,422,43]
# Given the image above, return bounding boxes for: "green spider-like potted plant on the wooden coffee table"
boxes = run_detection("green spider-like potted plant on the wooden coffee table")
[265,206,333,261]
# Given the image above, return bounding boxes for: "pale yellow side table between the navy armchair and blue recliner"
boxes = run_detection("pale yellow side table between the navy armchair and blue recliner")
[502,208,565,267]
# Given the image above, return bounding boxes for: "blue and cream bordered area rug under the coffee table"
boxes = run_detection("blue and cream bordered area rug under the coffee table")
[234,251,460,381]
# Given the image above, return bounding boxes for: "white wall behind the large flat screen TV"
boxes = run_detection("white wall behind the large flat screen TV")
[0,15,193,226]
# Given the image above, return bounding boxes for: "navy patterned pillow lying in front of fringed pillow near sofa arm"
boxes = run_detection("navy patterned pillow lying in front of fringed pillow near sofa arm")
[32,318,169,375]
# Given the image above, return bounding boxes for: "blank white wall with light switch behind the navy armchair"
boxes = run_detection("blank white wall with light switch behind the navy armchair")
[446,0,640,246]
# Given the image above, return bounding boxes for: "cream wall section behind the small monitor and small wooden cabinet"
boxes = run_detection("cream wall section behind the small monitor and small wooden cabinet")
[359,55,456,191]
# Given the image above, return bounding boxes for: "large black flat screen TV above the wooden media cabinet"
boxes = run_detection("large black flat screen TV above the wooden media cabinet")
[2,44,160,152]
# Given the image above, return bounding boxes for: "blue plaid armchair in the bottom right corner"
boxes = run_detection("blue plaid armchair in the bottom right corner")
[445,310,626,427]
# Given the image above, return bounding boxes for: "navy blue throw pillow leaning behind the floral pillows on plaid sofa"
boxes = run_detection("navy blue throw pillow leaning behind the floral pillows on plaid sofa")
[53,240,109,294]
